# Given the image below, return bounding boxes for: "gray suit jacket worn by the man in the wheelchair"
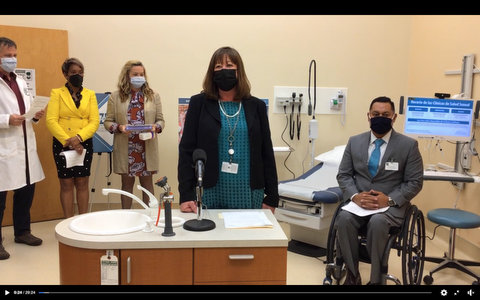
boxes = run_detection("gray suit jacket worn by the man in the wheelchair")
[337,129,423,217]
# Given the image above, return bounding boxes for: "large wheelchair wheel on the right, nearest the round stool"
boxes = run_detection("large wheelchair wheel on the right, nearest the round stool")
[399,205,425,285]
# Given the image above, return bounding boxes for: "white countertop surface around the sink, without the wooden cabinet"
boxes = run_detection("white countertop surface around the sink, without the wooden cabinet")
[55,209,288,249]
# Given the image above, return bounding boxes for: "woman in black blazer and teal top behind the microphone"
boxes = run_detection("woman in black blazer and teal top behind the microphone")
[178,47,278,212]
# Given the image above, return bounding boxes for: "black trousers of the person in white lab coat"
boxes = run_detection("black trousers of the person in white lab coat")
[0,183,35,243]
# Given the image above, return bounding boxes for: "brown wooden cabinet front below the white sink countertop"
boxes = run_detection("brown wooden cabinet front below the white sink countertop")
[59,243,287,285]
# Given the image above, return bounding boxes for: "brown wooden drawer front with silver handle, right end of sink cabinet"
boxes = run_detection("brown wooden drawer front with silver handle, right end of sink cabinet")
[194,247,287,284]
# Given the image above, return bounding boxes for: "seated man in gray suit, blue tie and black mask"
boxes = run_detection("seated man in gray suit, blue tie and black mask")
[334,97,423,285]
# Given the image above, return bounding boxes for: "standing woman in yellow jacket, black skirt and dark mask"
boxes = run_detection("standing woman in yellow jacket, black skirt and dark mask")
[46,58,100,218]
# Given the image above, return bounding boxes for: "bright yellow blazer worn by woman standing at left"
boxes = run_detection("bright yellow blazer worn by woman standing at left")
[46,86,100,145]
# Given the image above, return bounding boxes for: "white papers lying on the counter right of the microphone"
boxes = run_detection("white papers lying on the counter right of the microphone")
[222,211,273,228]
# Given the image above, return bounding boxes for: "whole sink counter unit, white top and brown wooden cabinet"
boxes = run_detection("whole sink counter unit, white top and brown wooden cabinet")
[55,209,288,285]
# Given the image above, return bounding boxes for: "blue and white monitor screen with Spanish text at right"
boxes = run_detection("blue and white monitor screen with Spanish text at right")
[404,97,474,142]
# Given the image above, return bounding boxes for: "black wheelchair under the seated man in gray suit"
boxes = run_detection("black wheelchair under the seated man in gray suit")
[323,204,425,285]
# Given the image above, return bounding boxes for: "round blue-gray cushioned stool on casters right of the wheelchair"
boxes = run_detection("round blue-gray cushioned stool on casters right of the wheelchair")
[423,208,480,284]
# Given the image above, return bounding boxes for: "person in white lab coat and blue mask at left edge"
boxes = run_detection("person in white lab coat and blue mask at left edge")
[0,37,45,259]
